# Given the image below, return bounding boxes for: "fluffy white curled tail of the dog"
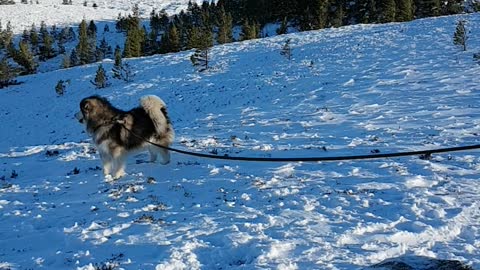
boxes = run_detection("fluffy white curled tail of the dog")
[140,95,175,145]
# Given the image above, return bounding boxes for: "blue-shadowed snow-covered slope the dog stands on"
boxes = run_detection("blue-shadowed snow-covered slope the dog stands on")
[0,10,480,269]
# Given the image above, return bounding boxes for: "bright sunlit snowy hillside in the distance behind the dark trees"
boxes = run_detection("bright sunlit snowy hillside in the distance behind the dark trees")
[0,0,203,34]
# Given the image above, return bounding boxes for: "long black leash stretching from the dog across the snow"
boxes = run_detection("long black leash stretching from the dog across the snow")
[117,121,480,162]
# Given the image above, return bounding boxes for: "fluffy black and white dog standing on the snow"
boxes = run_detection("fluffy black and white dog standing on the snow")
[75,95,175,179]
